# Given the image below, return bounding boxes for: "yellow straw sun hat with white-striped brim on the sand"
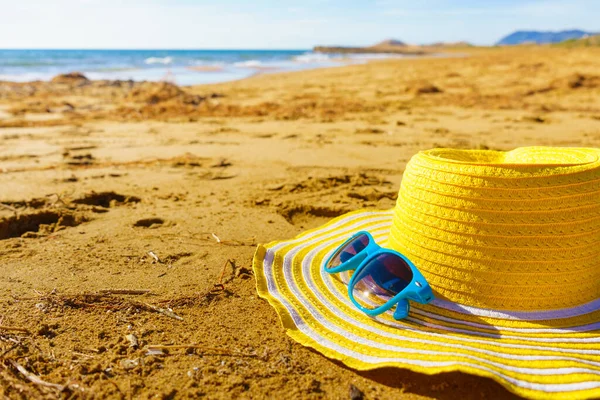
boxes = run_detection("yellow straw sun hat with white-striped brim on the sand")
[253,147,600,399]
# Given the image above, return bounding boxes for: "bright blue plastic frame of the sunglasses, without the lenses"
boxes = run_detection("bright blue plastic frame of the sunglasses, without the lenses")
[323,231,434,320]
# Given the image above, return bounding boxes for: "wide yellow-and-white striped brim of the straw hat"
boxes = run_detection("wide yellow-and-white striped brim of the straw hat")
[253,210,600,399]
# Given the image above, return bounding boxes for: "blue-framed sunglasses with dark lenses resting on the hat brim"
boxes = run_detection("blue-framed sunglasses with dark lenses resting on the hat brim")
[323,231,433,320]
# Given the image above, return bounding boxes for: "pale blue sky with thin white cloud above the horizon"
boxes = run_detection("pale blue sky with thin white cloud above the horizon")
[0,0,600,49]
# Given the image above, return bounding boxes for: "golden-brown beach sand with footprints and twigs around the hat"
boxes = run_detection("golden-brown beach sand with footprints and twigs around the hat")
[0,47,600,399]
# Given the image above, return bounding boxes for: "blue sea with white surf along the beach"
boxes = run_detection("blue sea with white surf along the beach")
[0,49,398,86]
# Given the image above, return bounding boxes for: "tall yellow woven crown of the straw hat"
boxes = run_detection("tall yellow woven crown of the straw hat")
[389,147,600,311]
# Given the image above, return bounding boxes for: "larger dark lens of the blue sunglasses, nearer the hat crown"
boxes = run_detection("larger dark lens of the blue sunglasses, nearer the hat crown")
[352,253,413,309]
